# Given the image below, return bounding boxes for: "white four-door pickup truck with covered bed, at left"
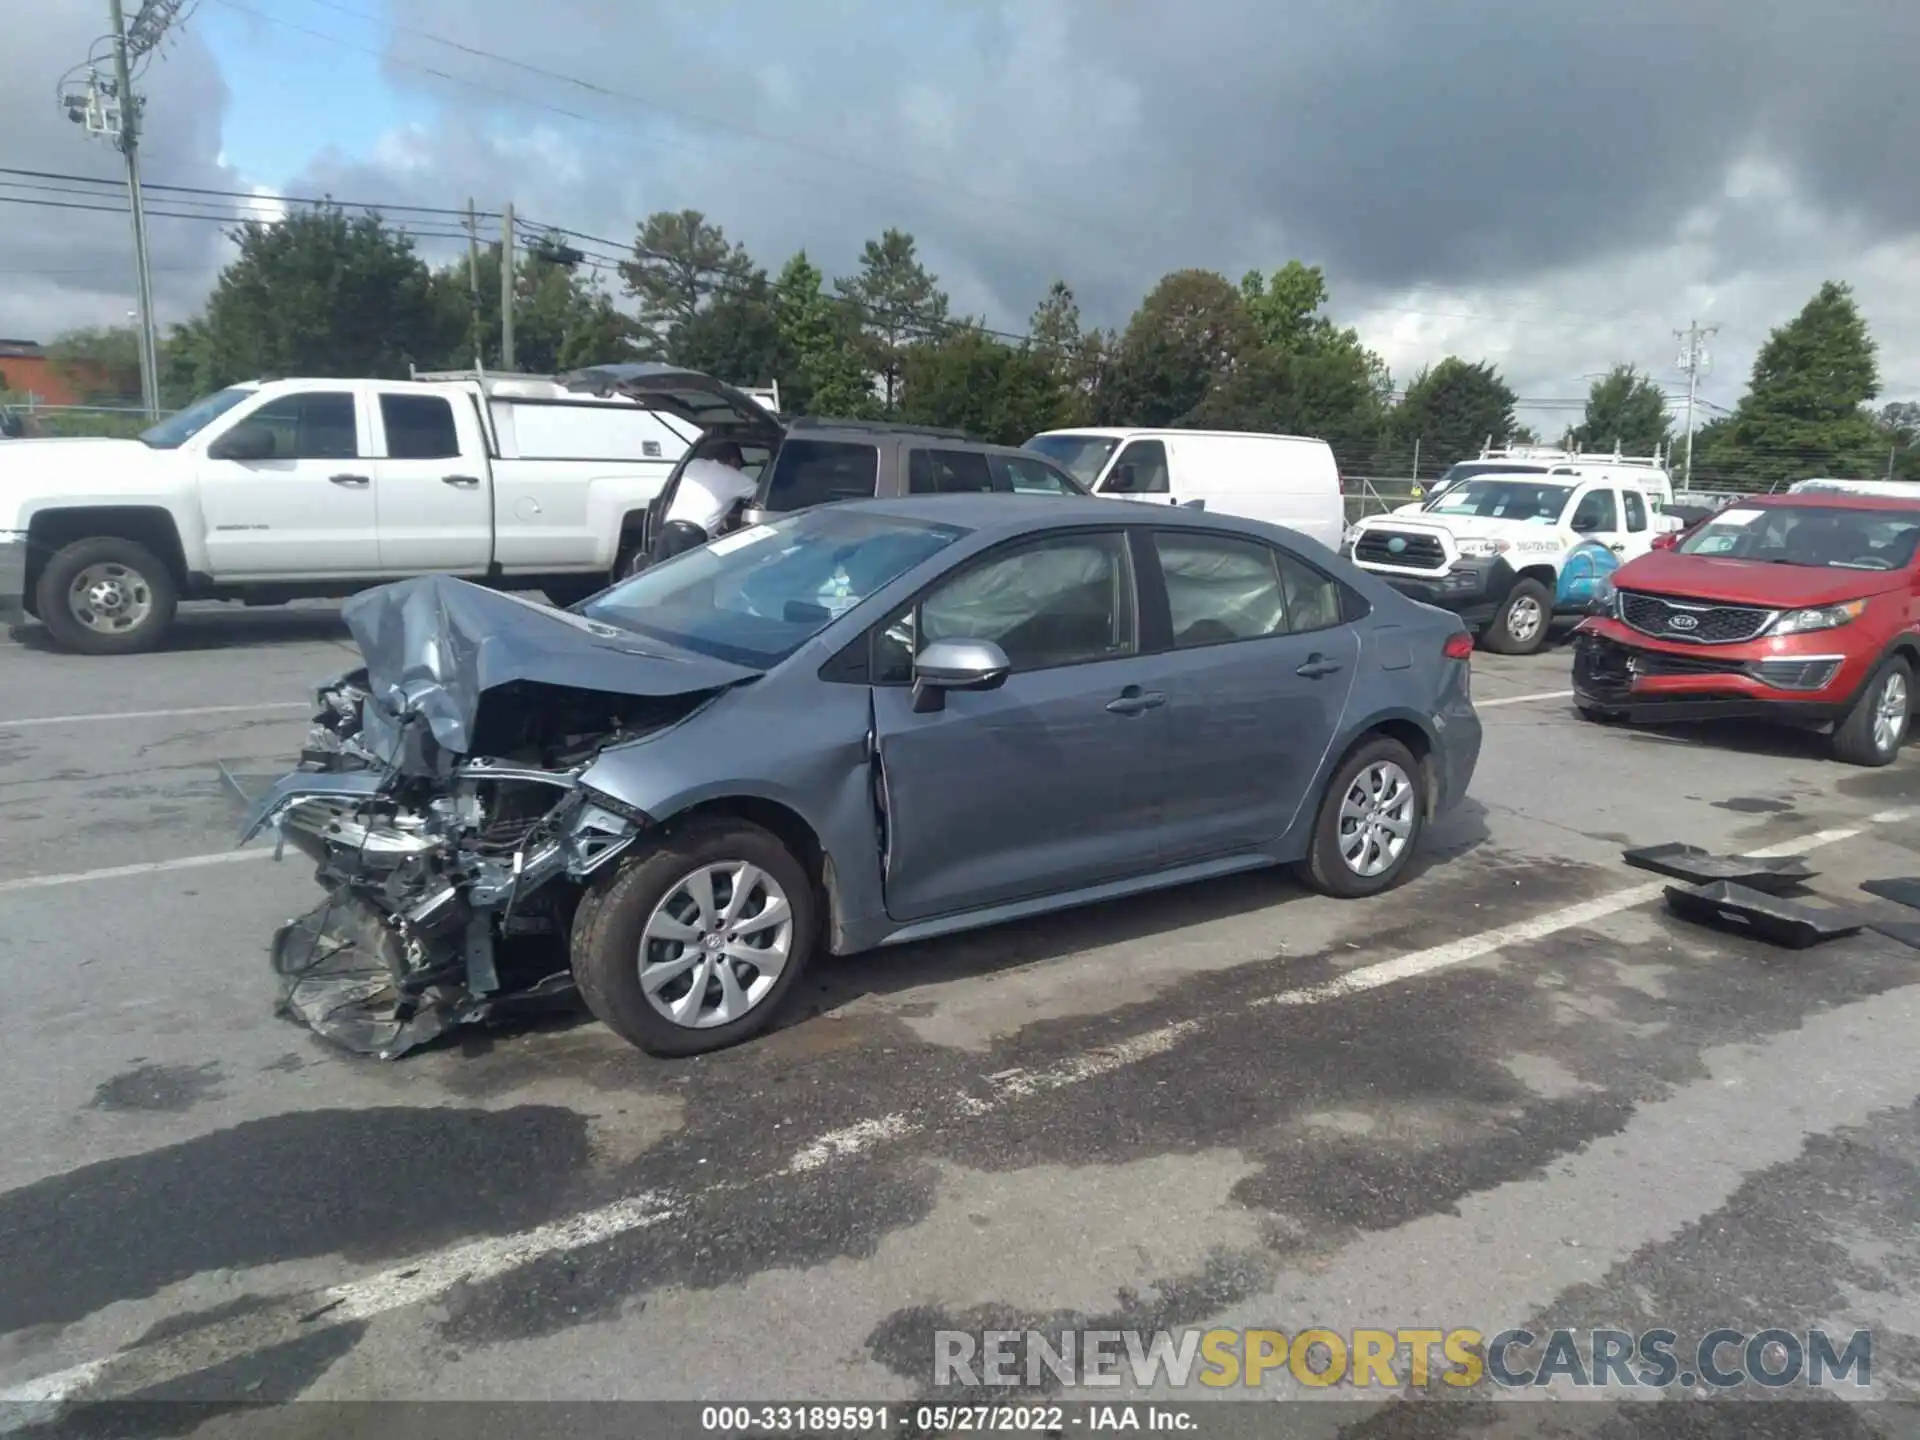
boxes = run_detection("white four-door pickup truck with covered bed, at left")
[0,365,778,655]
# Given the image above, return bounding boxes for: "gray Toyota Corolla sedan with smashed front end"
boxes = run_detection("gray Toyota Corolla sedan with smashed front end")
[242,495,1480,1056]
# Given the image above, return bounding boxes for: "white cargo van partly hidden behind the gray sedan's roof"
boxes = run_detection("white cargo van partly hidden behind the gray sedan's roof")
[1025,428,1346,549]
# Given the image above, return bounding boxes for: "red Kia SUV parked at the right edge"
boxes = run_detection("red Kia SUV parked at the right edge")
[1572,492,1920,766]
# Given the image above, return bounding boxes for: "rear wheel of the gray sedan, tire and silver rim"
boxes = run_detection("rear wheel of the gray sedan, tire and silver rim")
[1298,735,1427,899]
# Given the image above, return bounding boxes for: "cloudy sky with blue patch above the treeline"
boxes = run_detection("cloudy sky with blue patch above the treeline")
[0,0,1920,432]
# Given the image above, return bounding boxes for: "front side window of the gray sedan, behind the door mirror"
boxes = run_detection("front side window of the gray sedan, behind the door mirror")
[872,532,1137,685]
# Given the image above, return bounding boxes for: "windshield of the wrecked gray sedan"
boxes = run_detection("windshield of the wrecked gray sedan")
[582,507,966,670]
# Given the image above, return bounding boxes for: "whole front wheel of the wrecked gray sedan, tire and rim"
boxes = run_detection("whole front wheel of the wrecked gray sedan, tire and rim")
[572,820,818,1056]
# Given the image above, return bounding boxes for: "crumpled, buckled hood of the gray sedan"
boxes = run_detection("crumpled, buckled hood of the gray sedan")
[340,576,758,755]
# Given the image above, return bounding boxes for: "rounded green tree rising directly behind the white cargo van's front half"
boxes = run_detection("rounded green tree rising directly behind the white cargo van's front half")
[1094,271,1258,426]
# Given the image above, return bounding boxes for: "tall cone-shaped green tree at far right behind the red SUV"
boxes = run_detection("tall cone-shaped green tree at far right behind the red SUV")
[1720,280,1887,488]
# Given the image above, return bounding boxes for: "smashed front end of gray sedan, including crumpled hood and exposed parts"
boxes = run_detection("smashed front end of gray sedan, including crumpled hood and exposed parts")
[240,576,756,1060]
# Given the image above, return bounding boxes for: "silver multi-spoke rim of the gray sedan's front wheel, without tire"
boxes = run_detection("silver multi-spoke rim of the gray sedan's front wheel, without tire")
[639,860,793,1029]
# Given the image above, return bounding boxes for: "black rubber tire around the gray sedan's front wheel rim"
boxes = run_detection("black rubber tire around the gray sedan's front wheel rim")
[572,818,820,1058]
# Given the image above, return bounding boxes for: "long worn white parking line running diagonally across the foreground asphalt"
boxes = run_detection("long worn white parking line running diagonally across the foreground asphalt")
[0,808,1920,1432]
